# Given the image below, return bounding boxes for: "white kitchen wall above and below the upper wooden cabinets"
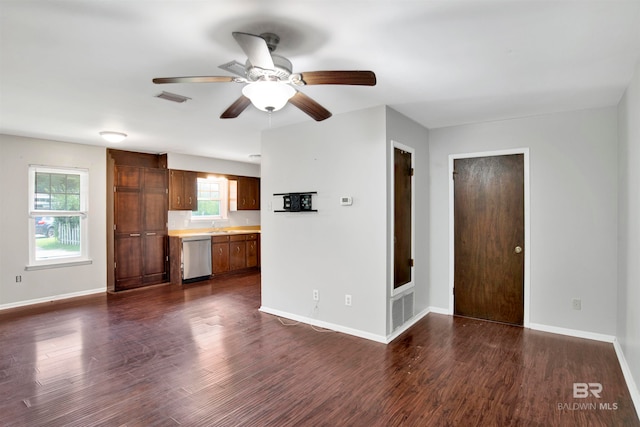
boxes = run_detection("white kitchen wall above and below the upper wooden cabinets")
[167,153,260,230]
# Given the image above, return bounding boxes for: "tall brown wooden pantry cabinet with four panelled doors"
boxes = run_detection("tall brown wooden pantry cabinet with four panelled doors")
[113,165,168,291]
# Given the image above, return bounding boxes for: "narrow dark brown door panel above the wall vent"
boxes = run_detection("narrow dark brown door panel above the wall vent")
[393,148,413,289]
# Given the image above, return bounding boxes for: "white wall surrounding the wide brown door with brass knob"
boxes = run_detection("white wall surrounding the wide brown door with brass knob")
[429,107,618,336]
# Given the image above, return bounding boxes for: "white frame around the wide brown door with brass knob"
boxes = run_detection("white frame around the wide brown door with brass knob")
[448,147,531,328]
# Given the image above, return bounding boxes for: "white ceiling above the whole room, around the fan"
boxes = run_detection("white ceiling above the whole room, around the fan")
[0,0,640,161]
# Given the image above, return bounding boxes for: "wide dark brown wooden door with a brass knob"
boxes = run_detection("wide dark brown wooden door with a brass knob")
[454,154,526,325]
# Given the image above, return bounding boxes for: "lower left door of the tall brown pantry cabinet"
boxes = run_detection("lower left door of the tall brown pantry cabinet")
[114,236,143,290]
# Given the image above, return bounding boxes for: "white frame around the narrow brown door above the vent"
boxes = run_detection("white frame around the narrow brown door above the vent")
[388,139,416,297]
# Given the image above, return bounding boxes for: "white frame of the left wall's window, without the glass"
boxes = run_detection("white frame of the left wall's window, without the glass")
[25,165,92,270]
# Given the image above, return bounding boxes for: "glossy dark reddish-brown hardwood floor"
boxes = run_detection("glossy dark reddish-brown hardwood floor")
[0,273,640,427]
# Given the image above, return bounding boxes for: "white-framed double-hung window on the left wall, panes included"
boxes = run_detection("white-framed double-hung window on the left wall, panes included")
[27,166,90,269]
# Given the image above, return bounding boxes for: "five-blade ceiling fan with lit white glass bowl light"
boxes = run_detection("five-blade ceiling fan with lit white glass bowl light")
[153,32,376,121]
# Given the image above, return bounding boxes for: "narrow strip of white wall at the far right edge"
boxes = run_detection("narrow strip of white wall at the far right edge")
[617,60,640,402]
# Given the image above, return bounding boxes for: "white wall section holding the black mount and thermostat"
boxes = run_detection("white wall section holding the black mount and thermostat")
[261,106,388,339]
